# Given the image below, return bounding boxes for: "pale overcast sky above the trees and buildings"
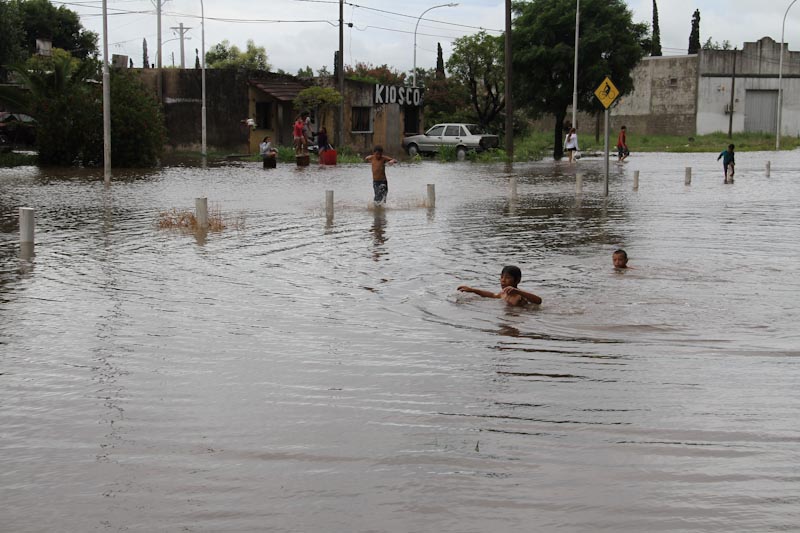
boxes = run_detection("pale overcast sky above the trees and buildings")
[65,0,800,74]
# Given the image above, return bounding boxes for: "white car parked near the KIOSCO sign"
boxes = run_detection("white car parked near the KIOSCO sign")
[403,124,500,159]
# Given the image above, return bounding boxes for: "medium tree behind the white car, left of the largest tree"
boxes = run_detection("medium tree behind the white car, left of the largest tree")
[447,31,504,128]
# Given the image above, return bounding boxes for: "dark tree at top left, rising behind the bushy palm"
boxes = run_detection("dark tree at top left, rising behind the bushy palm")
[15,0,97,59]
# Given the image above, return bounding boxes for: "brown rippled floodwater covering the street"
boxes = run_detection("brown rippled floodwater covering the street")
[0,152,800,533]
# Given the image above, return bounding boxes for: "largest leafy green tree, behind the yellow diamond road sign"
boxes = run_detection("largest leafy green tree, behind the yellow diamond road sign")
[512,0,648,159]
